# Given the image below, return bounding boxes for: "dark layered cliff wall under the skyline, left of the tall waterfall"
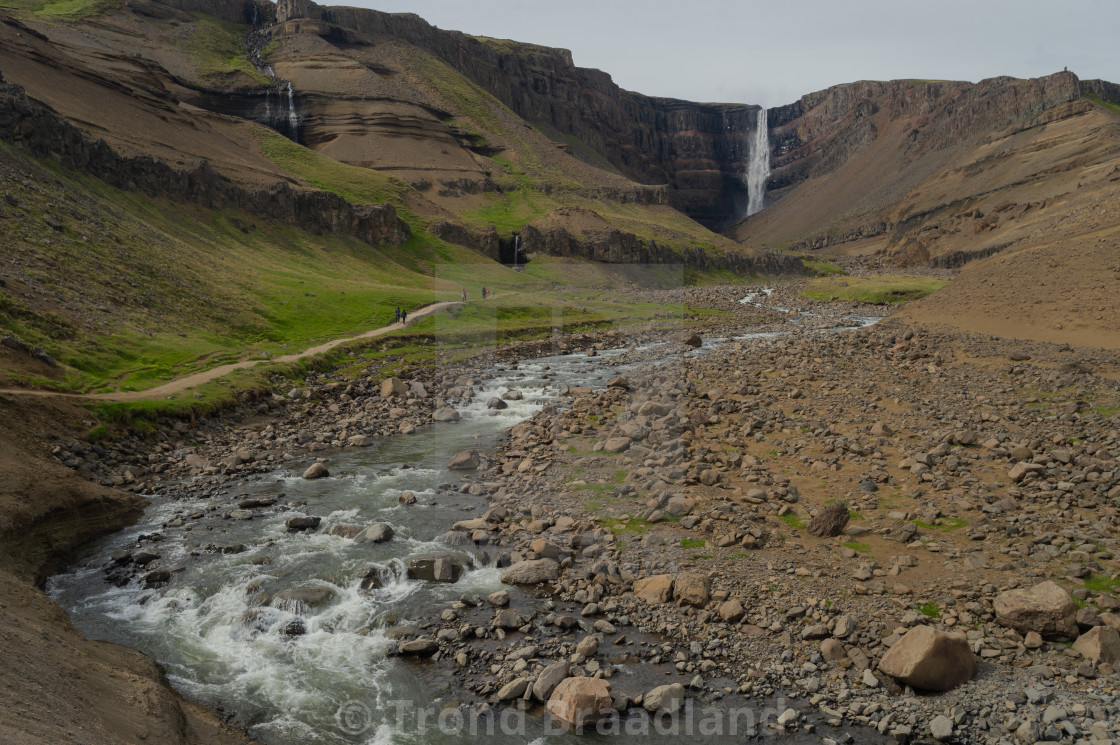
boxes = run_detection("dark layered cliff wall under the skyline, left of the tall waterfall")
[277,0,759,226]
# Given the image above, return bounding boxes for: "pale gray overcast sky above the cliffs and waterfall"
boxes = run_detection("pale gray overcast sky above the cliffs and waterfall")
[336,0,1120,106]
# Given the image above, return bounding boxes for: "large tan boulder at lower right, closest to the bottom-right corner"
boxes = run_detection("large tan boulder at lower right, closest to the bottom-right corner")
[879,626,977,691]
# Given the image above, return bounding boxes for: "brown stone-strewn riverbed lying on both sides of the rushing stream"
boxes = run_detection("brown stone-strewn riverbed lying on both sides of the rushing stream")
[41,288,1120,745]
